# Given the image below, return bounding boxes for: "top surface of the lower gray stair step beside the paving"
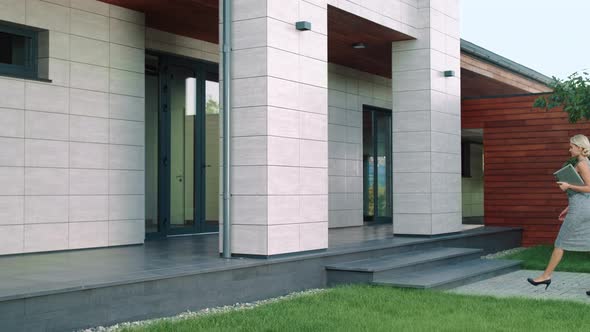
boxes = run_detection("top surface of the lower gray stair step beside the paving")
[372,259,521,289]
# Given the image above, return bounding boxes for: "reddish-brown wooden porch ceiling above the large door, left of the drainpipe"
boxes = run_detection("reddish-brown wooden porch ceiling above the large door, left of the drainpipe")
[100,0,219,43]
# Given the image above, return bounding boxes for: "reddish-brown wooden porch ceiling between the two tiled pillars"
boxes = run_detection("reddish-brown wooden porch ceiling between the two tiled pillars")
[328,6,414,78]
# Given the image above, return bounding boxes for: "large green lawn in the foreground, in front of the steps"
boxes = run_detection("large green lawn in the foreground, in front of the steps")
[123,286,590,332]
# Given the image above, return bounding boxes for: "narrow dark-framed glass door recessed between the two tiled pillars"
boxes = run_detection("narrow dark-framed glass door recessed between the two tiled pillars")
[363,106,392,222]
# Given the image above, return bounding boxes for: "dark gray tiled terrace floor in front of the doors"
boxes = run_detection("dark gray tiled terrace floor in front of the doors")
[0,224,424,300]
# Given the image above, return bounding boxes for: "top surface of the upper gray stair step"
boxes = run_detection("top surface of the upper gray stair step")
[326,247,482,272]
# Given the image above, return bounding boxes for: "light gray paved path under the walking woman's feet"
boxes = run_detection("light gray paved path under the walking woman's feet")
[448,270,590,304]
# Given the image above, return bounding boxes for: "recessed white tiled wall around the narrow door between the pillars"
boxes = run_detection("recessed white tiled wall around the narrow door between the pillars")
[328,64,395,228]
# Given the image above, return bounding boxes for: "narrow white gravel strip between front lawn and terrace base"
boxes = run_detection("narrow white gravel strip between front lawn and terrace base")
[78,288,326,332]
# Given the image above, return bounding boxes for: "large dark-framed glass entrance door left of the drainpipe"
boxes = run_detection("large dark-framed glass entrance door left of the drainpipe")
[146,54,219,237]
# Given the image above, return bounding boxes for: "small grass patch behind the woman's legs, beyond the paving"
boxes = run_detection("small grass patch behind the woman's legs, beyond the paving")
[501,245,590,273]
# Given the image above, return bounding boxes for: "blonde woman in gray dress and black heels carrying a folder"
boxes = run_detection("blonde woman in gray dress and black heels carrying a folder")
[527,135,590,295]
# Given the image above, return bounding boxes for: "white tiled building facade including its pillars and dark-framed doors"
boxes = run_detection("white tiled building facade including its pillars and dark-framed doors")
[0,0,461,257]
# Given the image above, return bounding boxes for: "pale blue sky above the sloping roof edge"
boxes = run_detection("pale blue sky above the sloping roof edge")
[459,0,590,79]
